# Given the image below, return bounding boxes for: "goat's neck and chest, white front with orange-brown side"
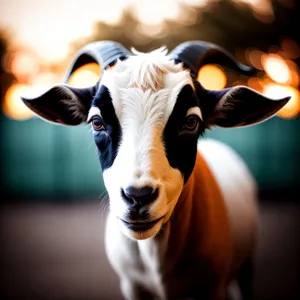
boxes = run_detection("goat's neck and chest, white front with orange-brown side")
[107,153,251,300]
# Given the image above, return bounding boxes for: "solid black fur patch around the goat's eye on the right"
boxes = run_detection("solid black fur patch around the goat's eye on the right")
[163,85,204,182]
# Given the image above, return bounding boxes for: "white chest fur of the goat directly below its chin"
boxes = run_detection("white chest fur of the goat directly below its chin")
[105,215,166,299]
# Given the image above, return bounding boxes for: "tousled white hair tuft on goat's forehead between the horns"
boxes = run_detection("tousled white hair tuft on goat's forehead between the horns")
[116,47,183,92]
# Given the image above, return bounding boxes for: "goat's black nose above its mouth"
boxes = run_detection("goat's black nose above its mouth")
[121,186,158,206]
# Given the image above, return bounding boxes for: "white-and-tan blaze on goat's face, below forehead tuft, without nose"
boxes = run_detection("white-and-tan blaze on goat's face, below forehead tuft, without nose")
[97,52,201,238]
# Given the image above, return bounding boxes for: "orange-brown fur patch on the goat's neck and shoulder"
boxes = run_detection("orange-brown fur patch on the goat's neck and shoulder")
[159,153,233,299]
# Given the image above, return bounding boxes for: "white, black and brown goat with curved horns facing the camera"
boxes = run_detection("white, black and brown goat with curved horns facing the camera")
[22,41,289,300]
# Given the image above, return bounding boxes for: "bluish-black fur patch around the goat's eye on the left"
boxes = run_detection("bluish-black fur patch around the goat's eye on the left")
[92,85,122,171]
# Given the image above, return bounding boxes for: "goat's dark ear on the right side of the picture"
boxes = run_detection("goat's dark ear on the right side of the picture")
[199,86,290,127]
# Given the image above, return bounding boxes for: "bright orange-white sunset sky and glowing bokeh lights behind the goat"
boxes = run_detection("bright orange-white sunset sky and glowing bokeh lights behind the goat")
[0,0,300,120]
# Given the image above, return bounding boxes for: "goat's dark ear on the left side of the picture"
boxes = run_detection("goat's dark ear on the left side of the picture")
[21,85,96,125]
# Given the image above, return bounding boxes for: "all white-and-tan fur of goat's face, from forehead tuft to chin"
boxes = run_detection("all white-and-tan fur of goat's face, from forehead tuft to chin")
[89,49,197,239]
